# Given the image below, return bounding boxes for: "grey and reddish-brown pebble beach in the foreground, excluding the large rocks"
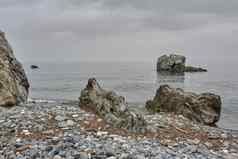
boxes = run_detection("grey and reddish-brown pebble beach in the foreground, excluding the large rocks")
[0,101,238,159]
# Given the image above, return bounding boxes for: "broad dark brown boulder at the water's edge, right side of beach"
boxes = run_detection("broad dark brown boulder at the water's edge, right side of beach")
[146,85,221,125]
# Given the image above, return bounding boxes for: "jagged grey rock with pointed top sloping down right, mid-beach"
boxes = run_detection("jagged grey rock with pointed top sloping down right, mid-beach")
[79,78,146,132]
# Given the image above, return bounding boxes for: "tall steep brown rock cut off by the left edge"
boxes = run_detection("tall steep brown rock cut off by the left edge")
[0,31,29,106]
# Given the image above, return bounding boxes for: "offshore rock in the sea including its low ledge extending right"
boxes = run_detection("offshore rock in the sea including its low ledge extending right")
[157,54,207,74]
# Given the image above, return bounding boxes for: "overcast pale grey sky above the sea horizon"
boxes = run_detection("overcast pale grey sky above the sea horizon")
[0,0,238,62]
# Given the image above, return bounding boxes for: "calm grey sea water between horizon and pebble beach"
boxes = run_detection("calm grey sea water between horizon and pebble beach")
[24,60,238,130]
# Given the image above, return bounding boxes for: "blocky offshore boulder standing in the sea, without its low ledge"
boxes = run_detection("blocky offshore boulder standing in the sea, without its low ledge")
[157,54,186,73]
